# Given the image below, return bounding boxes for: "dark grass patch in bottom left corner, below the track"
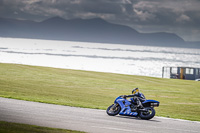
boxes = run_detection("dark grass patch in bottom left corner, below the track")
[0,121,83,133]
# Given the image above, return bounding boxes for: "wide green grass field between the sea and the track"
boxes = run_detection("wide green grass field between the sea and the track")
[0,64,200,121]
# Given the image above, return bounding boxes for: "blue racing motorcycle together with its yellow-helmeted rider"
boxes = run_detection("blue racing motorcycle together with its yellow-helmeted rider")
[106,88,160,120]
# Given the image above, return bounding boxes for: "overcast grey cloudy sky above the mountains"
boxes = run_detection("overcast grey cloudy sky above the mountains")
[0,0,200,41]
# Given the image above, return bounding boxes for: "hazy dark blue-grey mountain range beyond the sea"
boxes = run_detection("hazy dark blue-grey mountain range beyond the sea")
[0,17,200,47]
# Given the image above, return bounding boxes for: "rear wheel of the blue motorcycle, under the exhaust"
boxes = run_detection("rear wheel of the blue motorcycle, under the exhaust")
[139,107,156,120]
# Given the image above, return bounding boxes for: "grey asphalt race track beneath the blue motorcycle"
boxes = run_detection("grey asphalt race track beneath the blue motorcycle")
[0,98,200,133]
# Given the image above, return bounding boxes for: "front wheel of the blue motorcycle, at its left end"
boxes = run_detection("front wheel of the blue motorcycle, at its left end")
[106,104,121,116]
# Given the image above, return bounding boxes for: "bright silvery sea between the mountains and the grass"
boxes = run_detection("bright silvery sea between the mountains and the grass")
[0,38,200,78]
